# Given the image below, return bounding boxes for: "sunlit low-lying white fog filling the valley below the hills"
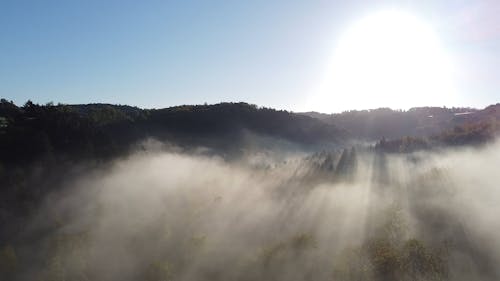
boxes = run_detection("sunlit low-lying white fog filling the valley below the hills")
[8,139,500,281]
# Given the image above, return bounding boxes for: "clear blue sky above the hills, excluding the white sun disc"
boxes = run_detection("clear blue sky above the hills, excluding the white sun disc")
[0,0,500,112]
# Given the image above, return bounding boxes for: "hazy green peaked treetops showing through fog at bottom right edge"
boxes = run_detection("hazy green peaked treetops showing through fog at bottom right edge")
[334,205,448,281]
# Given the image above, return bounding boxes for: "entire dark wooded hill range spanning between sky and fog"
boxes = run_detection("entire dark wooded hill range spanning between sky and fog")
[0,99,500,165]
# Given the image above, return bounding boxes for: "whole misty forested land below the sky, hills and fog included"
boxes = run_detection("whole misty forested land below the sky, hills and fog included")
[0,99,500,281]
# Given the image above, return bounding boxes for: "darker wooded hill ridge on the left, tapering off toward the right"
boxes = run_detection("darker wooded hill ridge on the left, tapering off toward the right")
[0,99,347,163]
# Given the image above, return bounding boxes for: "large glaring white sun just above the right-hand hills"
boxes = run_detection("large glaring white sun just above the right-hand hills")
[315,10,454,112]
